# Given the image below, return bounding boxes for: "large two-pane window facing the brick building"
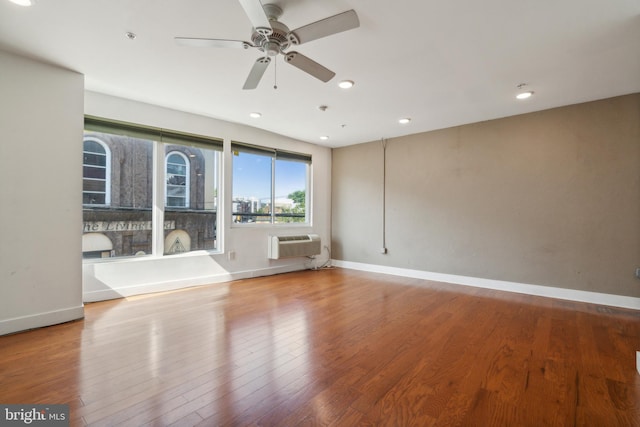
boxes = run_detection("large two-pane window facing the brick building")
[83,116,222,258]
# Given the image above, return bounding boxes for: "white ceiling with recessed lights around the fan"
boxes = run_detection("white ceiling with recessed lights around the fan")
[0,0,640,147]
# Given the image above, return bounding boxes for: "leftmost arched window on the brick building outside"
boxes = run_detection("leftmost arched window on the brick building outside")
[82,138,111,205]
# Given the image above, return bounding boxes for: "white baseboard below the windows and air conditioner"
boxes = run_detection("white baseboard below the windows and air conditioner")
[82,264,308,302]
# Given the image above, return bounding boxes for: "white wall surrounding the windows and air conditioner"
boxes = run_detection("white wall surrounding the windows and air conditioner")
[83,92,331,301]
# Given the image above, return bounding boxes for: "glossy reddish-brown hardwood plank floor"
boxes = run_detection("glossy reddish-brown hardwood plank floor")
[0,269,640,427]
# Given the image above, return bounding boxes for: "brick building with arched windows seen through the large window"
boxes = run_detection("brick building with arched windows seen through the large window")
[83,132,217,258]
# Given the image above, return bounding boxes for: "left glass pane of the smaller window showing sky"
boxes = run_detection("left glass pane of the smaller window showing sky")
[232,151,273,223]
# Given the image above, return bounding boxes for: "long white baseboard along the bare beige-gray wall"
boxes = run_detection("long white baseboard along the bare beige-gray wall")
[331,260,640,310]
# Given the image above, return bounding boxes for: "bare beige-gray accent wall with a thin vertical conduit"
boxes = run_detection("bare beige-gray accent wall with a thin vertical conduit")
[332,94,640,297]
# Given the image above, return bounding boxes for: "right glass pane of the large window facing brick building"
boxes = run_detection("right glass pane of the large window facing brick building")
[164,145,221,255]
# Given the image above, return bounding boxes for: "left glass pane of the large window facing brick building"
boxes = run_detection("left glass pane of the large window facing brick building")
[82,132,153,258]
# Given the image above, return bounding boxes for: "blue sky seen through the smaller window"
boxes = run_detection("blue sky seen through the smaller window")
[232,152,307,200]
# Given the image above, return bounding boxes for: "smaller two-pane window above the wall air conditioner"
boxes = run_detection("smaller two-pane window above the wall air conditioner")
[231,143,311,224]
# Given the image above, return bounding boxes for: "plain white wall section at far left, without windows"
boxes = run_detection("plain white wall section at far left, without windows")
[0,51,84,335]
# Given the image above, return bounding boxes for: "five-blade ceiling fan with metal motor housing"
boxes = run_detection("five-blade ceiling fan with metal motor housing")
[175,0,360,89]
